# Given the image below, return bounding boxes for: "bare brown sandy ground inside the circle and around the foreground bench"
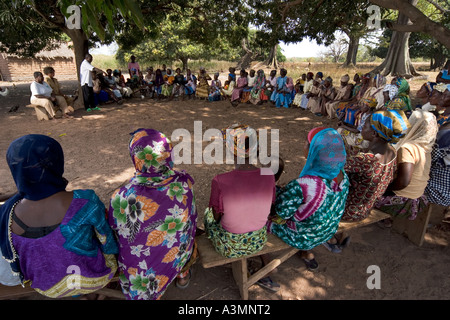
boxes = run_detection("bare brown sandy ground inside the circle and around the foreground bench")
[0,74,450,300]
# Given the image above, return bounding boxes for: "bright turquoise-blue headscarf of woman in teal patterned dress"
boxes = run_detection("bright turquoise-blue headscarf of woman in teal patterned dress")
[300,128,347,180]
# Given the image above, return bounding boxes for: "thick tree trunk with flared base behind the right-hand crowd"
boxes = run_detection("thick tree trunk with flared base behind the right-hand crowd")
[372,0,420,79]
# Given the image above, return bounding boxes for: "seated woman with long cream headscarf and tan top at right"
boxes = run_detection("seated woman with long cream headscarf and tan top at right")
[375,109,438,226]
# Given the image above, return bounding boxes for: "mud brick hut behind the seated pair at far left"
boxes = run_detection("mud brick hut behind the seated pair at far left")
[0,43,77,82]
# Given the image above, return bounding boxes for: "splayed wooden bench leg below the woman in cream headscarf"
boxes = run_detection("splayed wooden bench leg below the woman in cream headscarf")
[392,205,432,247]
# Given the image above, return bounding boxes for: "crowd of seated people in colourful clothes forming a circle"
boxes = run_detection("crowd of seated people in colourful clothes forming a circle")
[5,58,450,299]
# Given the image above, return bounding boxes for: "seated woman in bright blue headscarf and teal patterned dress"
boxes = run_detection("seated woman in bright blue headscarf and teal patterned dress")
[267,127,349,270]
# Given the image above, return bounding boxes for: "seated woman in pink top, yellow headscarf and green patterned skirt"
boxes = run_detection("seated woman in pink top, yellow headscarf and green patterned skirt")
[204,125,275,258]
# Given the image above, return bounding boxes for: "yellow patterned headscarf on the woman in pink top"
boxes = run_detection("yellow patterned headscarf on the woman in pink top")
[222,124,258,158]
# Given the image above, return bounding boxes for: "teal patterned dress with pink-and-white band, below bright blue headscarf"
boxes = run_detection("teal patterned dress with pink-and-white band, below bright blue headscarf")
[267,173,349,250]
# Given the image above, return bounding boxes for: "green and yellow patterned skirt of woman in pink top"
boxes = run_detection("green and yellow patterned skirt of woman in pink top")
[204,208,267,258]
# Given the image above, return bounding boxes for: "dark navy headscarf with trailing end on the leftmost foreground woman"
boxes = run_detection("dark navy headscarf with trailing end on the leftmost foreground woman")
[0,134,67,280]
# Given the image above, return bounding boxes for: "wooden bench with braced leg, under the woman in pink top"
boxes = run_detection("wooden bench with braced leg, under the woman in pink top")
[196,209,429,300]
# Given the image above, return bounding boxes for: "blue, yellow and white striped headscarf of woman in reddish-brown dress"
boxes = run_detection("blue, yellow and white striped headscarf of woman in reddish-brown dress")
[370,110,410,143]
